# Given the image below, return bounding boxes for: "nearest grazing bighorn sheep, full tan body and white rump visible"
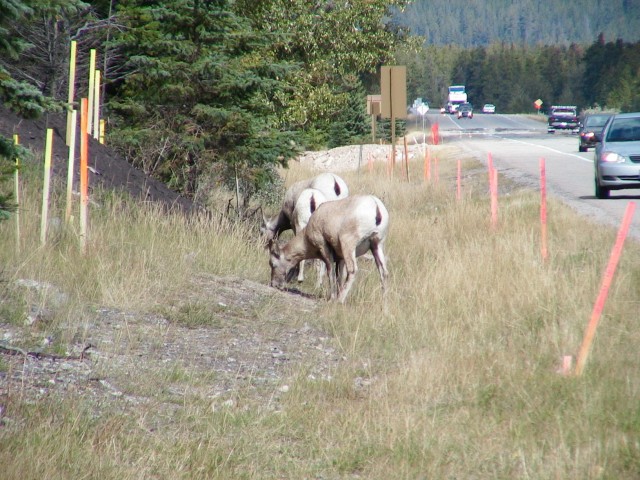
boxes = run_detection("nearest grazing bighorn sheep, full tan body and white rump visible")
[269,195,389,303]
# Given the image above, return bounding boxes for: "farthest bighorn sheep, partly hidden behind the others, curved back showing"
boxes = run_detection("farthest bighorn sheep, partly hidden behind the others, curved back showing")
[260,173,349,241]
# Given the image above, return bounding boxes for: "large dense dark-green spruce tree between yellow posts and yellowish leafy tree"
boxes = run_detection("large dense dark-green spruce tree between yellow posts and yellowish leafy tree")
[109,0,296,200]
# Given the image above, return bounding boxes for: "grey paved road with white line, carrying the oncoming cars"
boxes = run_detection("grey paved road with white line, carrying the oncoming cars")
[416,113,640,239]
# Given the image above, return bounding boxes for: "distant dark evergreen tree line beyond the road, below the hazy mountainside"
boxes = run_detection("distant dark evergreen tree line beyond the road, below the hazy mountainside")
[398,34,640,113]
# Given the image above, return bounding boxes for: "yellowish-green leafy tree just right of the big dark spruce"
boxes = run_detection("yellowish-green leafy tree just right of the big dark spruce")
[237,0,409,146]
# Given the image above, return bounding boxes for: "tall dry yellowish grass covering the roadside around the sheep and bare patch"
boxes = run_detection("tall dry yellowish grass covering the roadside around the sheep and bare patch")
[0,149,640,479]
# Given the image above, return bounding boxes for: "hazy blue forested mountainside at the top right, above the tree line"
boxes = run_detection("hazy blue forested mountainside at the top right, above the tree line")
[395,0,640,47]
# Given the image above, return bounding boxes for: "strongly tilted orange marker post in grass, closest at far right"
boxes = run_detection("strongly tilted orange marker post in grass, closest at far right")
[576,202,636,375]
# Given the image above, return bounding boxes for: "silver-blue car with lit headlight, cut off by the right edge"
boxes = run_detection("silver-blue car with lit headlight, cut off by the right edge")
[593,112,640,199]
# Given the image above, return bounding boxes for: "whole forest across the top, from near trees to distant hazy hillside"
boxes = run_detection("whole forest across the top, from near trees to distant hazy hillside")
[0,0,640,212]
